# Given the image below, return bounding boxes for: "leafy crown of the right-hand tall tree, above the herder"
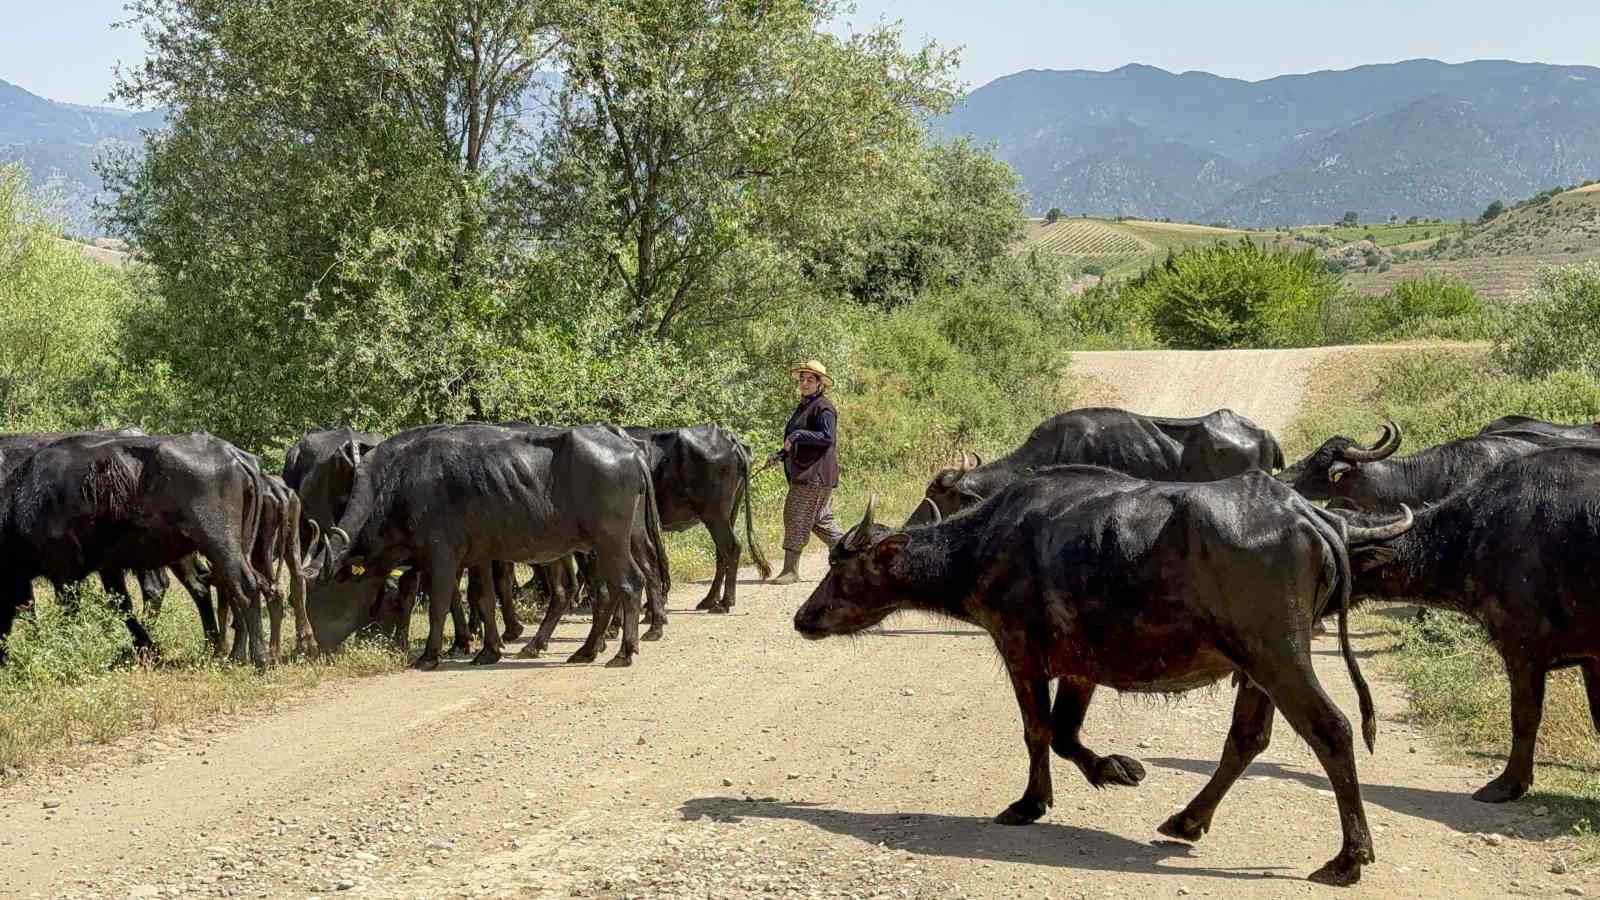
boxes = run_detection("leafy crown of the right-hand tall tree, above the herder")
[518,0,954,340]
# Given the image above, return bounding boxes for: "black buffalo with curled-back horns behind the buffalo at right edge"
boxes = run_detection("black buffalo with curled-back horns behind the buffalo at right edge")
[1278,421,1539,512]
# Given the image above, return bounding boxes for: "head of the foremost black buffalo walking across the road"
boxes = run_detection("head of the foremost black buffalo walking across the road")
[795,496,910,641]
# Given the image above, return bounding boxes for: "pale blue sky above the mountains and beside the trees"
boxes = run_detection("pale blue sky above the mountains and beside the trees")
[0,0,1600,104]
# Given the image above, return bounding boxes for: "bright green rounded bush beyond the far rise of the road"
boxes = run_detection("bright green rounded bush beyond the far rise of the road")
[1122,240,1339,349]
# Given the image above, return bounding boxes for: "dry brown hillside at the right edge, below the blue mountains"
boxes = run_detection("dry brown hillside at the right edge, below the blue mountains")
[1346,184,1600,299]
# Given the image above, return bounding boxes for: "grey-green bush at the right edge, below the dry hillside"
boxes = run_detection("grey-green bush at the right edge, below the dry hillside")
[1494,263,1600,378]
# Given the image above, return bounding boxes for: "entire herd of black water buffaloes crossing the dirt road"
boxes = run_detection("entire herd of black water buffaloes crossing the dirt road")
[0,408,1600,884]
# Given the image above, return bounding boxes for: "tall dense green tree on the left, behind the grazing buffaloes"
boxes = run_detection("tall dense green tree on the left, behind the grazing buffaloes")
[106,0,554,442]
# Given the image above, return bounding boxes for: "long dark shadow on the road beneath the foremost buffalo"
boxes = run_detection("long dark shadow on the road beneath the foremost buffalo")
[680,798,1285,881]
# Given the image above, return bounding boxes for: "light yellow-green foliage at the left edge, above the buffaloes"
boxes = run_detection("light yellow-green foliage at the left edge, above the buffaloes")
[0,165,130,431]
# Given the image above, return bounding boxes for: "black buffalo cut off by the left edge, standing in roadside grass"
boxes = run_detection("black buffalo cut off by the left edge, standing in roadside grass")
[0,434,269,668]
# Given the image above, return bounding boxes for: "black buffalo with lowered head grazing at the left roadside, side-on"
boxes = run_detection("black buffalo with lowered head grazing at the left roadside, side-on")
[307,423,670,669]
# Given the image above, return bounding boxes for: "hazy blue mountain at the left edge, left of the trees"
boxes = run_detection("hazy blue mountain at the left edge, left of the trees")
[0,82,162,235]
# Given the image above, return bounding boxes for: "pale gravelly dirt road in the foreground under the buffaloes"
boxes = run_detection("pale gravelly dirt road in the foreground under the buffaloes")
[0,339,1600,898]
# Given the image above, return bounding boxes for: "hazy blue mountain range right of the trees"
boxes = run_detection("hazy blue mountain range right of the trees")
[931,59,1600,227]
